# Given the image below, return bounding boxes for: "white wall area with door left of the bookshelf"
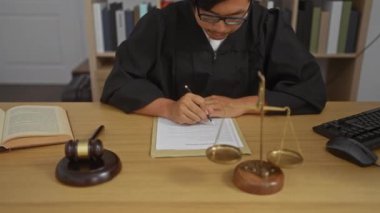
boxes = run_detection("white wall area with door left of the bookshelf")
[0,0,87,84]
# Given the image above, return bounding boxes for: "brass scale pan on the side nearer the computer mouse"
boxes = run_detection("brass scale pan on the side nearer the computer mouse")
[267,149,303,168]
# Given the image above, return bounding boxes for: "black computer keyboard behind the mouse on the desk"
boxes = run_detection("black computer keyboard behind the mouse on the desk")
[313,107,380,149]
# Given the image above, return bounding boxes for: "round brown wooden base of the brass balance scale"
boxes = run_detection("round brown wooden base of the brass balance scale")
[233,160,284,195]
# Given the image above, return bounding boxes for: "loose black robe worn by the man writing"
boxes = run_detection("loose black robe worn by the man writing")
[101,1,326,114]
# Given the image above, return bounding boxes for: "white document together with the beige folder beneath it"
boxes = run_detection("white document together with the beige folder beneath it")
[151,118,250,157]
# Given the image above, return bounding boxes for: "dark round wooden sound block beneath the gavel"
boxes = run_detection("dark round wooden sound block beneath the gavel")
[55,149,121,186]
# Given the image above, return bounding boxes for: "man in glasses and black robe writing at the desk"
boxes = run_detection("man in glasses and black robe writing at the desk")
[101,0,326,124]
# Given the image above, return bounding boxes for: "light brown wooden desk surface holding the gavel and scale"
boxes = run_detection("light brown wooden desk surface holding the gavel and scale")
[0,102,380,213]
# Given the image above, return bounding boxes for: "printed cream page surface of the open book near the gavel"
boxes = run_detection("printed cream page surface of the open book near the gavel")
[3,106,72,143]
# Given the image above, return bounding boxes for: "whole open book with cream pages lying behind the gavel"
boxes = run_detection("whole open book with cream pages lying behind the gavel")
[0,105,74,151]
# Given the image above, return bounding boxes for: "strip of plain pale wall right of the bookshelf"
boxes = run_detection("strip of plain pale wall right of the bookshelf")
[357,0,380,101]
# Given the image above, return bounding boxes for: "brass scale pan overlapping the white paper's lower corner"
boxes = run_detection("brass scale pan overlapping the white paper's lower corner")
[206,144,242,164]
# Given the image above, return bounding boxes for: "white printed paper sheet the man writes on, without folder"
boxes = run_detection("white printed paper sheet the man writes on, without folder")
[156,118,243,150]
